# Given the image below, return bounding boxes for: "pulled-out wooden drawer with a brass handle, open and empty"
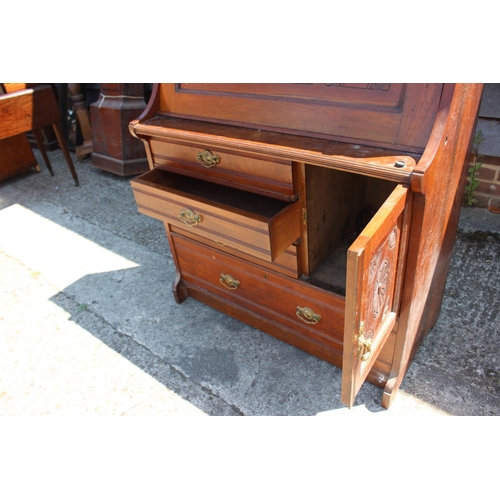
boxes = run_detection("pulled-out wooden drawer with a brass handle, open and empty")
[131,169,300,262]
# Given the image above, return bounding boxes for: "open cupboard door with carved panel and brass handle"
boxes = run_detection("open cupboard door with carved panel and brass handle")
[341,185,409,407]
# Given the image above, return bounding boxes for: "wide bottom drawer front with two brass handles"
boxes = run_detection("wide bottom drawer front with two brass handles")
[172,235,344,344]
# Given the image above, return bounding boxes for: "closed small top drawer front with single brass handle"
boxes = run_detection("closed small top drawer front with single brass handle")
[150,139,295,200]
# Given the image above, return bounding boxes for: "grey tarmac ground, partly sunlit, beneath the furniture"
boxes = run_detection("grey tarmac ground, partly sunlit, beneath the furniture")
[0,150,500,418]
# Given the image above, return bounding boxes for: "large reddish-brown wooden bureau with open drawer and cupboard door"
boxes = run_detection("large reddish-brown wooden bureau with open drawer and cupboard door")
[130,83,482,408]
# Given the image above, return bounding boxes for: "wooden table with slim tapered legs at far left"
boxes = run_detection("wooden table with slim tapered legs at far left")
[0,84,79,186]
